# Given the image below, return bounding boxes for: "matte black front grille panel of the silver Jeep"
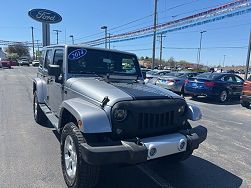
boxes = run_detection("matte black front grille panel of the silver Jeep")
[111,98,187,139]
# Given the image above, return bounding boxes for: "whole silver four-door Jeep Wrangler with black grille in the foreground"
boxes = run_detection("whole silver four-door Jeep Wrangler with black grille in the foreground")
[33,45,207,187]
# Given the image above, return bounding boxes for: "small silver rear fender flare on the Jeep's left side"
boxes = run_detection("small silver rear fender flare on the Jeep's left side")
[33,78,47,103]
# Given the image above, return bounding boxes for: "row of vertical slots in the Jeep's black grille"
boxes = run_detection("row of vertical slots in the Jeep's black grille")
[138,111,174,130]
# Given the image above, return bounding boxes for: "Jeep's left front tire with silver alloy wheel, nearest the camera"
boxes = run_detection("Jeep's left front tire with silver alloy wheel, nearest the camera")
[61,122,100,188]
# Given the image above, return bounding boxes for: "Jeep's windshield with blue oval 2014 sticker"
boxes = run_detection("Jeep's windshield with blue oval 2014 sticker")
[67,47,141,76]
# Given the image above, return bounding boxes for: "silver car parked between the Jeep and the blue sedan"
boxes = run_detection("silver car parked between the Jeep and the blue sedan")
[153,72,198,94]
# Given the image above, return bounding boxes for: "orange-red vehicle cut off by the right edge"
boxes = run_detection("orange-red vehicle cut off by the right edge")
[241,76,251,108]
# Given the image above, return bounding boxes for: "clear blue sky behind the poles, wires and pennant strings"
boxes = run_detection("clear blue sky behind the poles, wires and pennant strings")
[0,0,251,65]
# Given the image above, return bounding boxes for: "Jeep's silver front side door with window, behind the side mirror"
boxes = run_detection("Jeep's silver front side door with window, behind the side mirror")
[47,48,64,115]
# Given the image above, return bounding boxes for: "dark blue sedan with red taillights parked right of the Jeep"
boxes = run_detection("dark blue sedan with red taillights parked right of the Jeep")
[185,72,244,102]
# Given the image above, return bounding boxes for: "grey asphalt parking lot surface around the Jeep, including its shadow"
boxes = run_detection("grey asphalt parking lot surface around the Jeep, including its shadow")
[0,67,251,188]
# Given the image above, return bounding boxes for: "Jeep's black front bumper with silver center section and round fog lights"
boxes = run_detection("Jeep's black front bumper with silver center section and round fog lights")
[81,126,207,165]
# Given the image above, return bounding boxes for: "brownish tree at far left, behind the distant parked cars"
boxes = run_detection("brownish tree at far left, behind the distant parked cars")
[5,43,30,57]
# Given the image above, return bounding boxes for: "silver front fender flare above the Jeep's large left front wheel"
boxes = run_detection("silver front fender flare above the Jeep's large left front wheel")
[59,98,112,133]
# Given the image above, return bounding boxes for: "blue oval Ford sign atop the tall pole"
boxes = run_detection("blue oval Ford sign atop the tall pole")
[28,9,62,23]
